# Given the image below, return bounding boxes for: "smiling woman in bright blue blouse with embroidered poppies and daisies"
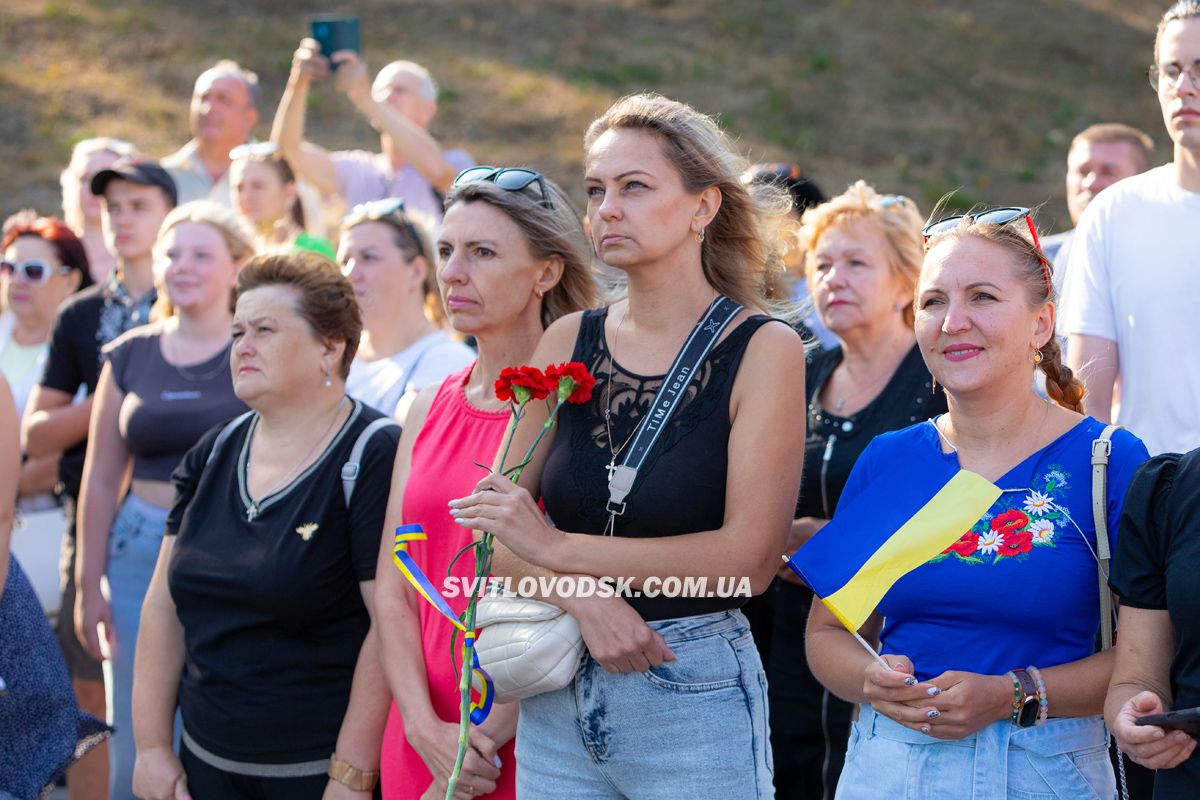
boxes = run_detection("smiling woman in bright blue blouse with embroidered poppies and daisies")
[806,209,1147,800]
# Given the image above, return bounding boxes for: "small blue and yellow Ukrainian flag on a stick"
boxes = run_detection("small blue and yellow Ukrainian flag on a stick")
[787,458,1001,632]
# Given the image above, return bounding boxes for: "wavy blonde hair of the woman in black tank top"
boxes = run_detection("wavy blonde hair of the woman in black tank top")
[583,94,794,315]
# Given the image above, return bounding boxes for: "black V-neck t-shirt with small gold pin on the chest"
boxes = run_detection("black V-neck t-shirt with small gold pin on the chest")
[167,401,400,764]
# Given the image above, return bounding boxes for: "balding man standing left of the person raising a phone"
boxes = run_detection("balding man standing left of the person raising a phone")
[161,61,258,206]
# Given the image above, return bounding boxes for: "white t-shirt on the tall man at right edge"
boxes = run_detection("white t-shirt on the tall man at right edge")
[1060,164,1200,455]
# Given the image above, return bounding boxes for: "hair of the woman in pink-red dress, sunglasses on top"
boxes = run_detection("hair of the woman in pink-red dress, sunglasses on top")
[446,176,600,326]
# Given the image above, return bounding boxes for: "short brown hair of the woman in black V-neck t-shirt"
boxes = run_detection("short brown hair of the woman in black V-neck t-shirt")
[234,251,362,380]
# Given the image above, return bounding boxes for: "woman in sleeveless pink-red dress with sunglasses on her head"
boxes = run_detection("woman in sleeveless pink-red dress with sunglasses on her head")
[376,165,598,800]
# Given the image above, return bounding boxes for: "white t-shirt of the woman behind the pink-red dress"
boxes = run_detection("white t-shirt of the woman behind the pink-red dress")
[346,331,475,422]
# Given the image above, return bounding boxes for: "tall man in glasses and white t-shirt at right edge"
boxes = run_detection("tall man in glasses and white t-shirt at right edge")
[1061,0,1200,455]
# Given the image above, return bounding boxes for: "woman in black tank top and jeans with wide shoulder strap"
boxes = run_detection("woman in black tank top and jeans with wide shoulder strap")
[454,95,804,800]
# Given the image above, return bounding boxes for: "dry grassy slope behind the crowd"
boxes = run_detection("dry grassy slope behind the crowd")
[0,0,1170,229]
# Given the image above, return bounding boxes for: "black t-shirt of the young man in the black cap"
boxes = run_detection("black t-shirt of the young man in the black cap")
[41,276,157,496]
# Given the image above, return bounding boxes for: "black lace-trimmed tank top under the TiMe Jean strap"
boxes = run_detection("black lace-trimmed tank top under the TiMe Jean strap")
[541,308,770,620]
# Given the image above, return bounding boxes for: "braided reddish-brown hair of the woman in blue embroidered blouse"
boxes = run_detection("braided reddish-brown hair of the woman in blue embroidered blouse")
[925,216,1084,414]
